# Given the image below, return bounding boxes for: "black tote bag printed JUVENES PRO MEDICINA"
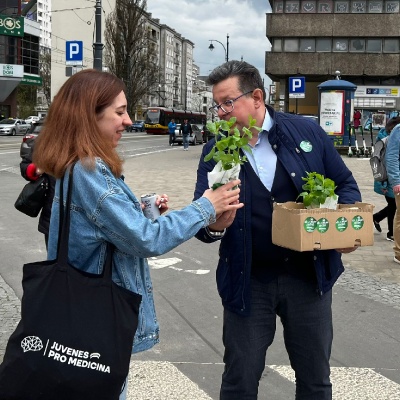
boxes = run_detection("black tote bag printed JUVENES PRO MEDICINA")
[0,163,141,400]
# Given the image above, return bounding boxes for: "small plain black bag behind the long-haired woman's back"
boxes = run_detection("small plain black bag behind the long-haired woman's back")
[14,175,49,218]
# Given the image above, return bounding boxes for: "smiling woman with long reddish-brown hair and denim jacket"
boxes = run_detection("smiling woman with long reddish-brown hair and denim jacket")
[33,69,243,399]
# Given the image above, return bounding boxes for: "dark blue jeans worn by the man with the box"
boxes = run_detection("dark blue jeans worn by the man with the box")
[220,275,333,400]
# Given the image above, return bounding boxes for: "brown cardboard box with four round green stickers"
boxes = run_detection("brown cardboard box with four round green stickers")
[272,201,374,251]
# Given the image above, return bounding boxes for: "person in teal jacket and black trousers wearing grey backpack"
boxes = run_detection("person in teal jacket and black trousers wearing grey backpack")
[373,117,400,242]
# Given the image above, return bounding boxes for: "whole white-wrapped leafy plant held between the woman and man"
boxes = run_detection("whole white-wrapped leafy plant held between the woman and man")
[204,116,262,189]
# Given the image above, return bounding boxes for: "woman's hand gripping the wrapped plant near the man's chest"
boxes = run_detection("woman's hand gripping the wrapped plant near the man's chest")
[203,179,244,215]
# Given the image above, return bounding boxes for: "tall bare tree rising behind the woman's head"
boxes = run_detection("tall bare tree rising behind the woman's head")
[104,0,158,116]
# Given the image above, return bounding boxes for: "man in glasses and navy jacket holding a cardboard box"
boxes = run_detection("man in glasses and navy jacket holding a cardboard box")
[195,61,361,400]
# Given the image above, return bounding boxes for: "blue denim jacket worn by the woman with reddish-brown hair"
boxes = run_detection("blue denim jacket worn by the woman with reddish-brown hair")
[48,159,215,353]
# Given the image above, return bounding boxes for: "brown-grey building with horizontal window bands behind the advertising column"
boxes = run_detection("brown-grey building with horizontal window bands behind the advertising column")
[265,0,400,120]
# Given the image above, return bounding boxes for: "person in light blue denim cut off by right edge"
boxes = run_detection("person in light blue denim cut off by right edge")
[385,120,400,264]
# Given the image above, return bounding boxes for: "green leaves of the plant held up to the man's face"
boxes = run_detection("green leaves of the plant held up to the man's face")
[204,116,262,171]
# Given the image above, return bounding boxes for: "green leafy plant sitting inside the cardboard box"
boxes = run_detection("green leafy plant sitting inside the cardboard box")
[297,172,338,208]
